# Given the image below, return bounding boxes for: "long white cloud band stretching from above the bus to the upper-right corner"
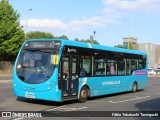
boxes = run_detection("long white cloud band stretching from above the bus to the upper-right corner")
[21,0,160,34]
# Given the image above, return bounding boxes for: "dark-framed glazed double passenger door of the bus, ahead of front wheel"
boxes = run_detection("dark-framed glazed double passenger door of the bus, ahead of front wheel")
[61,55,78,100]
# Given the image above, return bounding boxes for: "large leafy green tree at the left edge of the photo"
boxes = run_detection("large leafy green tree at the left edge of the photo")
[0,0,24,60]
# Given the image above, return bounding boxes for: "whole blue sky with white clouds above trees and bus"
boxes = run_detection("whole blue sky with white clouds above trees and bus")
[9,0,160,46]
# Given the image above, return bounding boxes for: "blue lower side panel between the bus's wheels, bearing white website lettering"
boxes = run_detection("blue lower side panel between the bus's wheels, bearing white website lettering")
[93,76,132,96]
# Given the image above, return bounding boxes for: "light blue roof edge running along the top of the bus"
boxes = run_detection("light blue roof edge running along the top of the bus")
[26,38,147,55]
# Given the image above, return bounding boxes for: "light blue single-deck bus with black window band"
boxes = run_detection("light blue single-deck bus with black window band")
[12,39,148,102]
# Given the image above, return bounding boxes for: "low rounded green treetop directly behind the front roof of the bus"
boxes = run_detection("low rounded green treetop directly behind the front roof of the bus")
[26,31,54,39]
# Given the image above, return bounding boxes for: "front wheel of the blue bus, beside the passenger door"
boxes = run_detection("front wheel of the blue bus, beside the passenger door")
[79,86,88,103]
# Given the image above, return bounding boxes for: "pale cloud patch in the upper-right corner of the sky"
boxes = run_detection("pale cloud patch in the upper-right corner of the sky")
[103,0,160,13]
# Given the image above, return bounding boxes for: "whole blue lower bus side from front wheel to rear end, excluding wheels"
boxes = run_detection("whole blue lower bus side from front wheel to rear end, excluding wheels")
[91,76,148,96]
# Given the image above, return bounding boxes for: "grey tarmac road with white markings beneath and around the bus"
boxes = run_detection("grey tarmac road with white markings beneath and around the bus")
[0,76,160,120]
